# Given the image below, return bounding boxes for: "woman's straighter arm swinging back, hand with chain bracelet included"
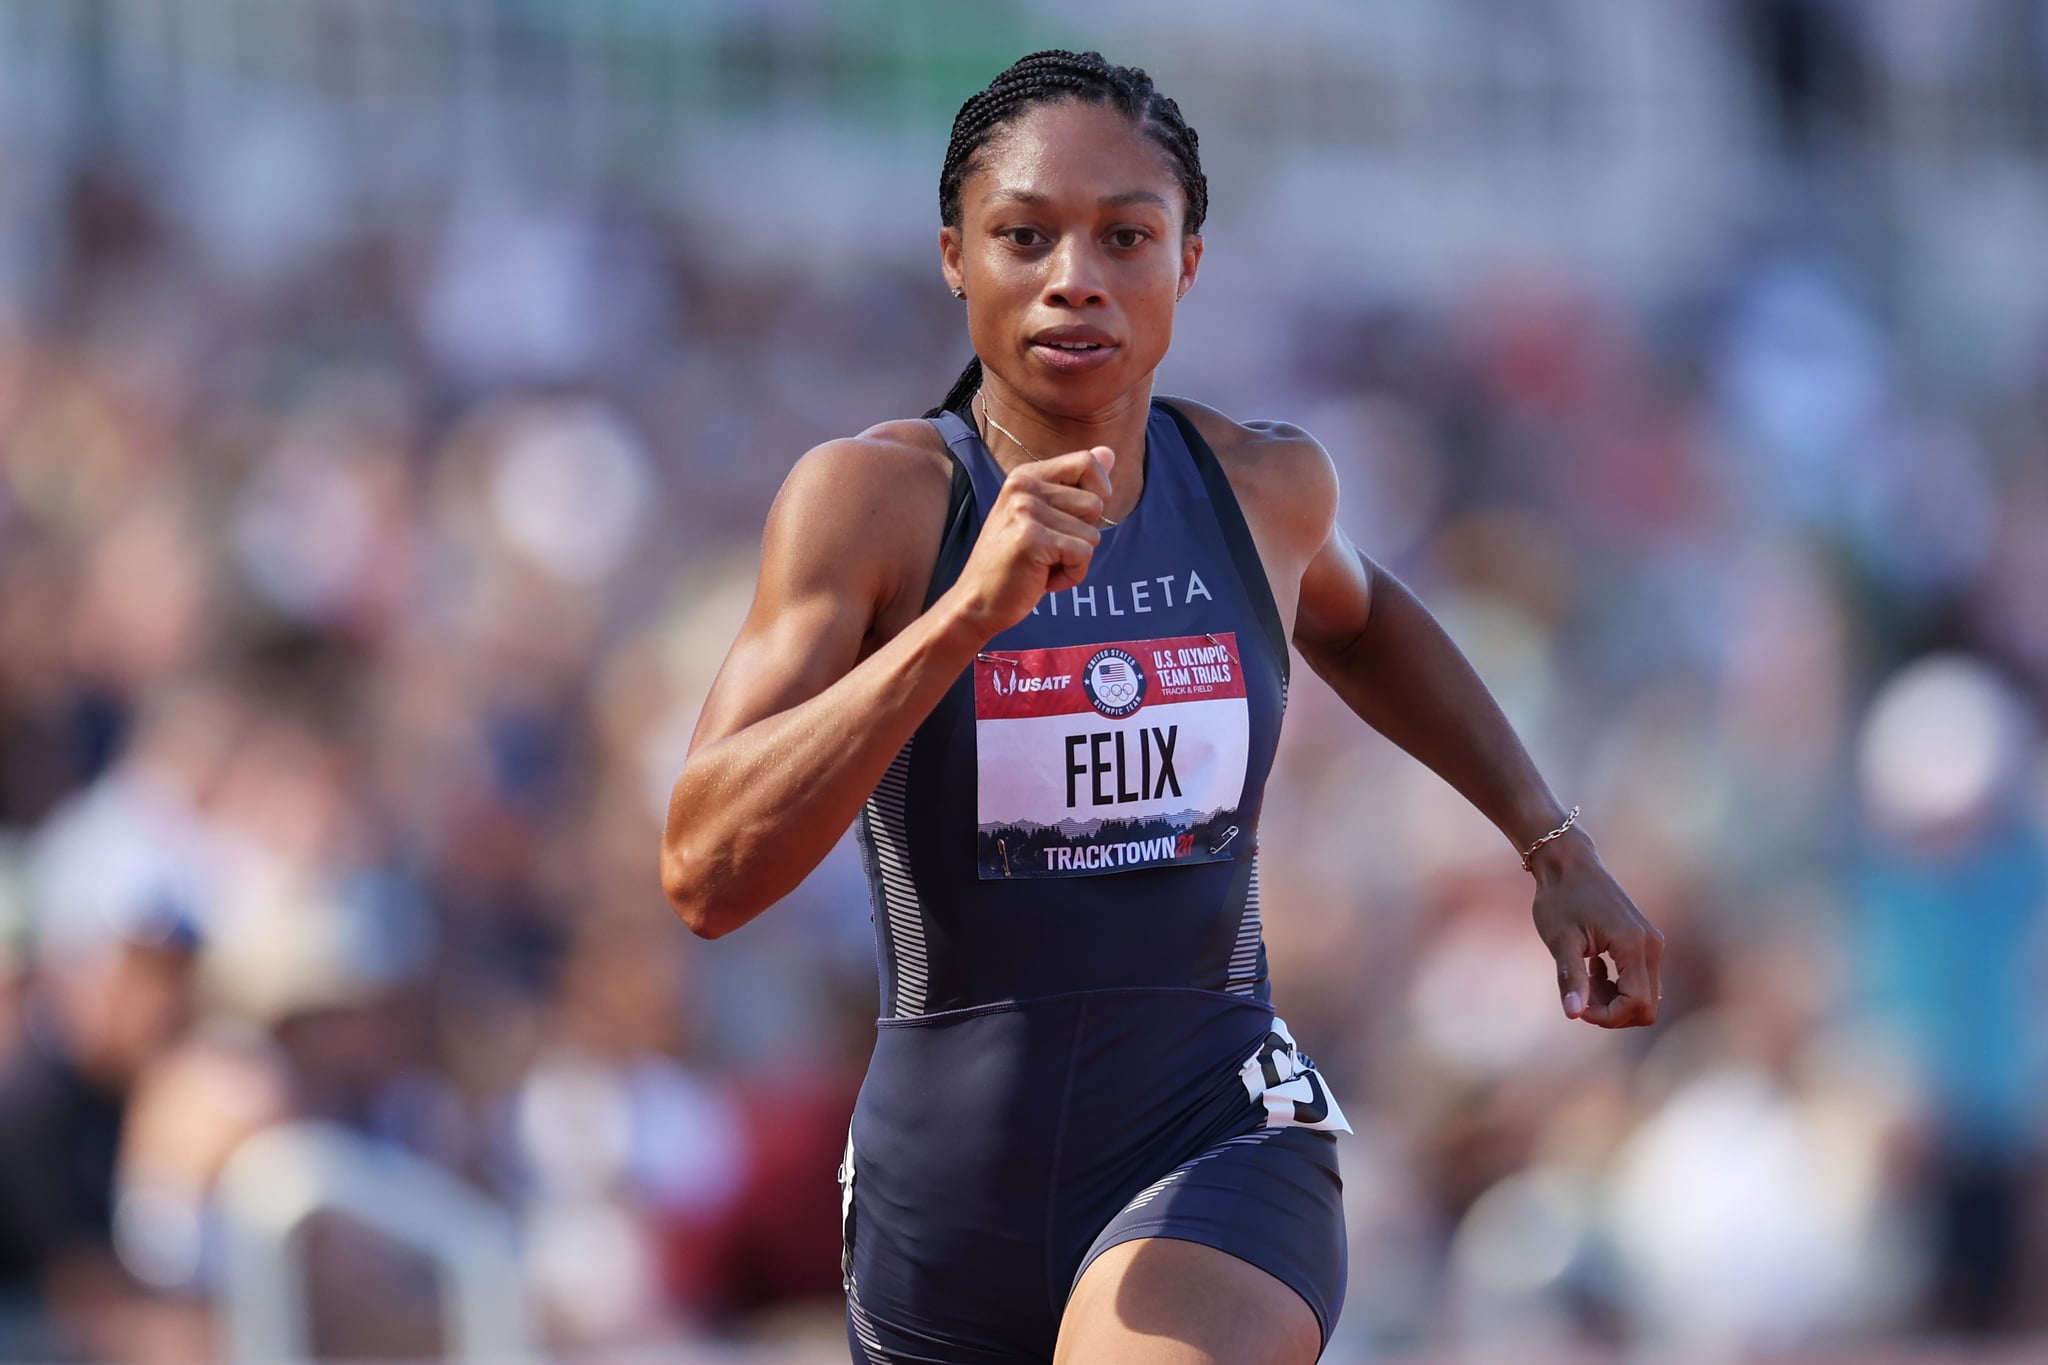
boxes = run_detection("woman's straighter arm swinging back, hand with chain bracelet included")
[1294,491,1663,1029]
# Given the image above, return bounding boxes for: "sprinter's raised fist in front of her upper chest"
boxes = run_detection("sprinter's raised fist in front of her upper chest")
[954,446,1116,636]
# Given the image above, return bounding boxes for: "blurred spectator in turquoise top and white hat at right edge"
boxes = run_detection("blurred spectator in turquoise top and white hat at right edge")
[1855,655,2048,1334]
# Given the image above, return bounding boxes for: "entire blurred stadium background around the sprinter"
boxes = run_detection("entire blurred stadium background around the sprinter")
[0,0,2048,1365]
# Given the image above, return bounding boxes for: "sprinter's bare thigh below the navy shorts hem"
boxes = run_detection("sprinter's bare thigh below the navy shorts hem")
[1053,1236,1323,1365]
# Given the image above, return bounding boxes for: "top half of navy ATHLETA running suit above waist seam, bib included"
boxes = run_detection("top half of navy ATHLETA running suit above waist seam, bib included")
[860,403,1288,1019]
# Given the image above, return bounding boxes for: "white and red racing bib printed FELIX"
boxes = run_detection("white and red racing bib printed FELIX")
[975,632,1251,880]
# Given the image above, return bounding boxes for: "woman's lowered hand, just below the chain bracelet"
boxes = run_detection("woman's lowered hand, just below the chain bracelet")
[1532,835,1663,1029]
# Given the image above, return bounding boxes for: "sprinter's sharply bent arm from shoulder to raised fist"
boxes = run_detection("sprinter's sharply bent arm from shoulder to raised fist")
[662,440,1108,937]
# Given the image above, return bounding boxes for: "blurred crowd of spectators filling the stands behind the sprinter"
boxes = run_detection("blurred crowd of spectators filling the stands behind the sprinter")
[0,6,2048,1361]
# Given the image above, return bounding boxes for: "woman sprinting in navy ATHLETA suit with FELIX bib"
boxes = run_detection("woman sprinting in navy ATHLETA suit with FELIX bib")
[662,51,1661,1365]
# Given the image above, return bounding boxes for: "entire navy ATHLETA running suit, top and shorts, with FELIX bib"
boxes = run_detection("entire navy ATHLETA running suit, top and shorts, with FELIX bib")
[842,403,1346,1365]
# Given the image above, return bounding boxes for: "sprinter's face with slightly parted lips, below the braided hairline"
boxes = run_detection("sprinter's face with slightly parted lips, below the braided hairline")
[940,100,1202,417]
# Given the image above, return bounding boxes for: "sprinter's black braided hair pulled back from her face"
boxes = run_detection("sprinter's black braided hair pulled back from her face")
[926,47,1208,417]
